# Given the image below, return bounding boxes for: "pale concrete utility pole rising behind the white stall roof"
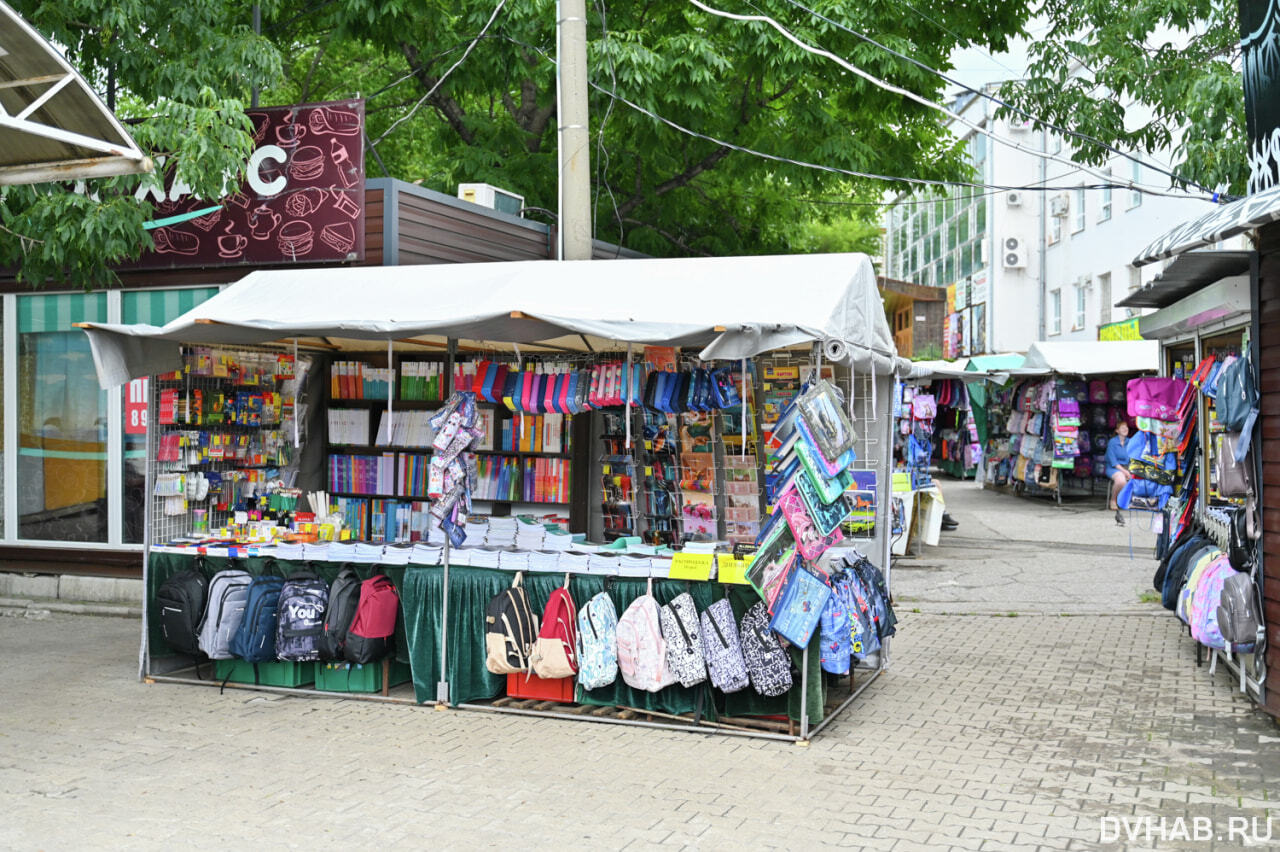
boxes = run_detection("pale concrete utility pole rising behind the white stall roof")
[556,0,591,260]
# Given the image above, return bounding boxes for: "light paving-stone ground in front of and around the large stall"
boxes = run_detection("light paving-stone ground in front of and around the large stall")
[0,481,1280,851]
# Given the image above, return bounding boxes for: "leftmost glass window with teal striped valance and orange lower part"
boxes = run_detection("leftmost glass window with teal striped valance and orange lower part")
[18,293,106,541]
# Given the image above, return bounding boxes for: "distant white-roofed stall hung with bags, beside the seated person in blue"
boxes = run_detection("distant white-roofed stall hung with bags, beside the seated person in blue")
[984,340,1158,503]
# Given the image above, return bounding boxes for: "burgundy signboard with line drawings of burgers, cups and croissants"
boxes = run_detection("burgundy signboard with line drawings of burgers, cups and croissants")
[133,100,365,269]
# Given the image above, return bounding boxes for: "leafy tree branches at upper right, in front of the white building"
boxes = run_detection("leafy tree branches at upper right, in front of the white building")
[1002,0,1248,194]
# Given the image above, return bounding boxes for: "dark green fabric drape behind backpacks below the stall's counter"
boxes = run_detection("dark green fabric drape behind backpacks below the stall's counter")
[147,554,826,724]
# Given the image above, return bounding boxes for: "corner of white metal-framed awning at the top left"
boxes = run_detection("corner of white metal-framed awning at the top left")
[0,3,151,185]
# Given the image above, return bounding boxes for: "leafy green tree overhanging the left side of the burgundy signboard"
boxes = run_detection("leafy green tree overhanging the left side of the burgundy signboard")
[0,0,280,287]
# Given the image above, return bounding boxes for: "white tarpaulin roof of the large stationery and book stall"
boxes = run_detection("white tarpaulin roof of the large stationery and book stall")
[82,255,909,388]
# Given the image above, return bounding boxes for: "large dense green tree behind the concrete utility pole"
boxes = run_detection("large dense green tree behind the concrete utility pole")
[273,0,1027,255]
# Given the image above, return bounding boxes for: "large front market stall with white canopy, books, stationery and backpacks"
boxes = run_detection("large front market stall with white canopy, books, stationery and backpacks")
[86,255,906,739]
